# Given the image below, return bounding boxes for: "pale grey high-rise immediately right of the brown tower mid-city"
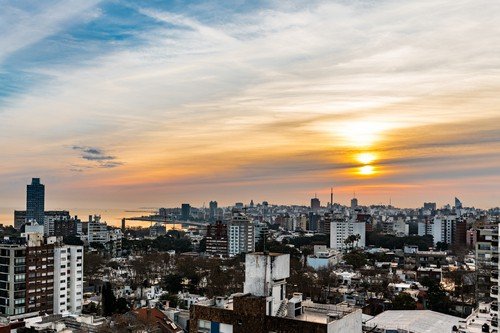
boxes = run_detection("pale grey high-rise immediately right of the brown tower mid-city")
[228,212,255,257]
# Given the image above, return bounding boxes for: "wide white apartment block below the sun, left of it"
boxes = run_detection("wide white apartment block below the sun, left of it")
[330,219,366,250]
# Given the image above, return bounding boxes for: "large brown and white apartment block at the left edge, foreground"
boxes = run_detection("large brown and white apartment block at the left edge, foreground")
[0,222,83,322]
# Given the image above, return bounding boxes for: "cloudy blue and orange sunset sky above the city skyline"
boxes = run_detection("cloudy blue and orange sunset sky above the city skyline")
[0,0,500,215]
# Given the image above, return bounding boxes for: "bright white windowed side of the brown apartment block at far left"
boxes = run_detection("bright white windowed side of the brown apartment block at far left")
[54,245,83,314]
